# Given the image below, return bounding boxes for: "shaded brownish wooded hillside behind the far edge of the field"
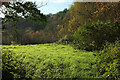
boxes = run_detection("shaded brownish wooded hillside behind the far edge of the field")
[2,9,68,44]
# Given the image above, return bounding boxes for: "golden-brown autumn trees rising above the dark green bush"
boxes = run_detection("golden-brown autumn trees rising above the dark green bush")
[58,2,120,45]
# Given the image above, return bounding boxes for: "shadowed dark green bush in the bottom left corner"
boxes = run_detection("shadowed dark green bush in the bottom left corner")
[2,49,29,80]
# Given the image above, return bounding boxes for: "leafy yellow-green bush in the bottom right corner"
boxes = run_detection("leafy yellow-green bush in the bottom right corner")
[96,41,120,79]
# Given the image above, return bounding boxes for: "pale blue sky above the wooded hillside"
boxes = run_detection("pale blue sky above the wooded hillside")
[26,0,73,14]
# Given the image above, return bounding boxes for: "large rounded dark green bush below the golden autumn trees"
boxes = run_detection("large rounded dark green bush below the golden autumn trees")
[73,21,120,50]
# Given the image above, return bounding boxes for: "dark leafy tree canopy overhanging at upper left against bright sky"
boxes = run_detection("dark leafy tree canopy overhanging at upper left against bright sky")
[3,1,46,27]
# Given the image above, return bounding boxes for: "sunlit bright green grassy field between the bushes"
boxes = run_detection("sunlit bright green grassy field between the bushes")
[2,43,98,79]
